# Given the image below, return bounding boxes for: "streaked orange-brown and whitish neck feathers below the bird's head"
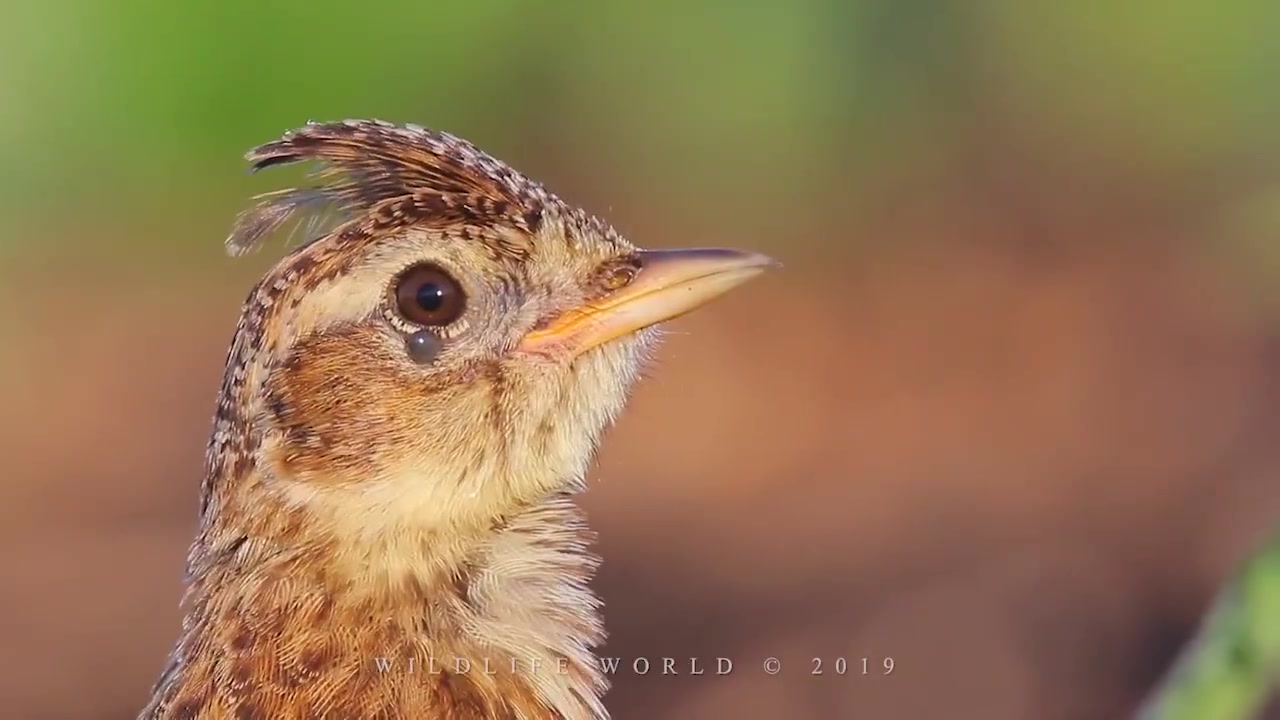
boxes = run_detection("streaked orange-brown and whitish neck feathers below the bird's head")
[141,482,608,720]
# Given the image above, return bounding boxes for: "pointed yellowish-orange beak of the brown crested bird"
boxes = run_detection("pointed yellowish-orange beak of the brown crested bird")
[520,249,778,356]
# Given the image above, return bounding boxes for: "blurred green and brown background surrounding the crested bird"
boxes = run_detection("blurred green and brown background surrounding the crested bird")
[0,0,1280,720]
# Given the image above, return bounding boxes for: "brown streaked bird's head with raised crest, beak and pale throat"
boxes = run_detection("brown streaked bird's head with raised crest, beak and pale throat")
[205,120,772,563]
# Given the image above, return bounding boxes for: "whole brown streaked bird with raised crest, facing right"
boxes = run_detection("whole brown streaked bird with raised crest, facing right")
[138,120,777,720]
